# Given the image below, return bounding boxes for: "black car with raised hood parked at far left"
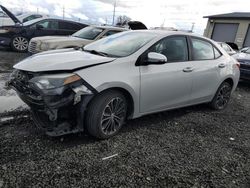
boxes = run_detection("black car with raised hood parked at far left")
[0,5,88,52]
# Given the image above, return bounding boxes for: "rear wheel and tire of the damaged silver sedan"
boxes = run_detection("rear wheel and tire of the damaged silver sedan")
[210,82,232,110]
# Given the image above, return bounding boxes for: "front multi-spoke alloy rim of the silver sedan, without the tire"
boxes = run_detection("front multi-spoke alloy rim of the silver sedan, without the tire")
[101,97,126,135]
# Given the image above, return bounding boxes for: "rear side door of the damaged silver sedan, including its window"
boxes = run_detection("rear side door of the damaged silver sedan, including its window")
[190,37,227,103]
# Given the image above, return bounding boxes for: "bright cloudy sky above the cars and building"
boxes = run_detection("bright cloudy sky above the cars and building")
[0,0,250,34]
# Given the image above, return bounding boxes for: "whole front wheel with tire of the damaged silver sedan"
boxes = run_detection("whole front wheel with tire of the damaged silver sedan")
[86,90,128,139]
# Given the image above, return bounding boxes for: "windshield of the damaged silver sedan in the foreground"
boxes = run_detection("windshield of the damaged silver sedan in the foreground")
[84,31,157,57]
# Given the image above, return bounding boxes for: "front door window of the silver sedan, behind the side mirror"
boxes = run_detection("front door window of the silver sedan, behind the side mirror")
[149,36,188,62]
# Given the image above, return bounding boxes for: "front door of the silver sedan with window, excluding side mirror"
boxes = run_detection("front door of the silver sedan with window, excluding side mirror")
[140,36,192,113]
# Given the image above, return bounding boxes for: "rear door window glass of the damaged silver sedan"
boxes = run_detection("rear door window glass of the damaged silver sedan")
[191,38,214,60]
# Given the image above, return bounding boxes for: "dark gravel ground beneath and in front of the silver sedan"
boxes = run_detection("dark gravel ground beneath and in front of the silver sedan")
[0,52,250,188]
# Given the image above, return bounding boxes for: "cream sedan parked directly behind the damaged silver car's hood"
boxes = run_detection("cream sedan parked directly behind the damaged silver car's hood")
[28,26,128,54]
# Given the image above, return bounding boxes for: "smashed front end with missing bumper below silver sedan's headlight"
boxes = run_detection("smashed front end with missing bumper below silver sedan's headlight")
[7,72,97,136]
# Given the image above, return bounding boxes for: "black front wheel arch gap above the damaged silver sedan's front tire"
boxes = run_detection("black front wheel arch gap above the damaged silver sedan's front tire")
[87,87,134,118]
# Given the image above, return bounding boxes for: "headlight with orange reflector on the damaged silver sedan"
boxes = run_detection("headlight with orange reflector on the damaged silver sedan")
[29,74,81,90]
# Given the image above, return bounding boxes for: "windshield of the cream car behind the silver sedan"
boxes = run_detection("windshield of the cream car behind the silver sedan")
[72,27,104,40]
